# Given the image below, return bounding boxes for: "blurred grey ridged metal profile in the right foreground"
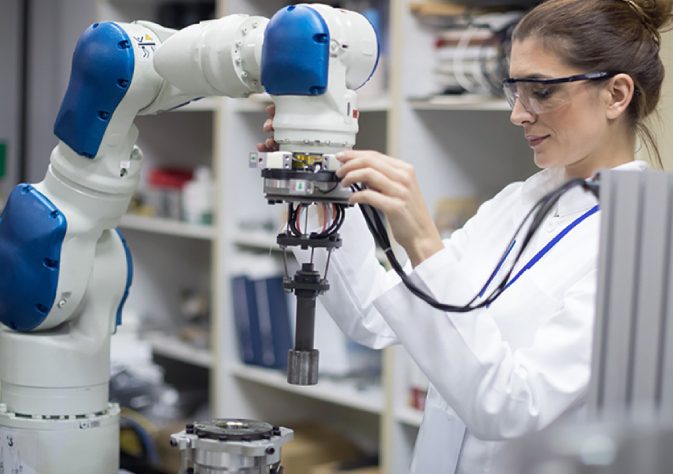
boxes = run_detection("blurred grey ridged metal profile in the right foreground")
[589,171,673,420]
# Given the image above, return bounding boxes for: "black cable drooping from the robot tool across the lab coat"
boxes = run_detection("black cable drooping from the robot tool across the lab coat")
[352,179,599,313]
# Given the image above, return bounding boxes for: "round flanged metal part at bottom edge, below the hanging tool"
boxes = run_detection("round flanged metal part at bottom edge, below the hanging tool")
[170,419,294,474]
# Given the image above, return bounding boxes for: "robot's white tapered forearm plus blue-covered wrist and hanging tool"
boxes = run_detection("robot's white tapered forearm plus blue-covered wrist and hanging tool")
[154,4,379,385]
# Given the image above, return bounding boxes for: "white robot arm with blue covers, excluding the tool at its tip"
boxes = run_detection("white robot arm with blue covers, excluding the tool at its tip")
[0,5,378,474]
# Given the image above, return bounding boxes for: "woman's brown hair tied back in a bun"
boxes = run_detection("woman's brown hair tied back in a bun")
[512,0,673,167]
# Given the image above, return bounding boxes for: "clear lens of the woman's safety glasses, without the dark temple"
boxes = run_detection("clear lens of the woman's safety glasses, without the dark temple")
[503,82,571,115]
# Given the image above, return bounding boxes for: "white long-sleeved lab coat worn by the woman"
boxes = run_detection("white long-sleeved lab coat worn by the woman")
[299,161,647,474]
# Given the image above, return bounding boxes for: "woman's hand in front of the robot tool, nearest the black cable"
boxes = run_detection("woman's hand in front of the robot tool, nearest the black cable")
[336,150,444,267]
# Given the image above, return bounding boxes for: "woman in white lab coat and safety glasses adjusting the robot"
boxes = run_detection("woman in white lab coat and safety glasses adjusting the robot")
[260,0,672,474]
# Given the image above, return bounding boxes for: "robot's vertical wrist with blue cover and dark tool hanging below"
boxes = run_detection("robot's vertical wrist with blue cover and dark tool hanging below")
[250,4,379,385]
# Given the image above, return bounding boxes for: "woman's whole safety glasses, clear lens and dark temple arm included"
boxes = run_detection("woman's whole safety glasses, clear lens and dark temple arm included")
[502,72,617,115]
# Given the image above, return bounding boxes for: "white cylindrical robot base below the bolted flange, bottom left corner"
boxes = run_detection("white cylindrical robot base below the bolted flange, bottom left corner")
[0,404,119,474]
